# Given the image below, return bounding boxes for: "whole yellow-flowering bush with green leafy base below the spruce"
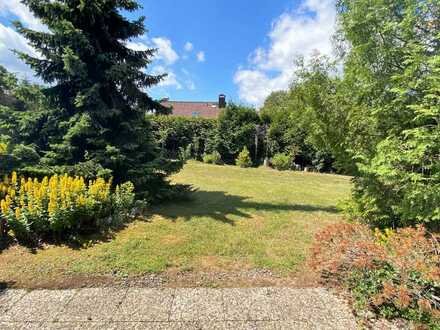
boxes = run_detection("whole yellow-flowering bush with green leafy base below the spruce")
[0,172,134,241]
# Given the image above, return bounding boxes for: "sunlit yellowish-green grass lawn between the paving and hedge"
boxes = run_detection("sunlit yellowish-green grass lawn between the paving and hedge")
[0,162,350,287]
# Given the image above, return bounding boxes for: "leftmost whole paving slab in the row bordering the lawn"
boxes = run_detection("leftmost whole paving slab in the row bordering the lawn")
[3,290,75,322]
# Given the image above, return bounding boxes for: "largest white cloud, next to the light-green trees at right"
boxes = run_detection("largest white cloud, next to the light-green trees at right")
[234,0,336,106]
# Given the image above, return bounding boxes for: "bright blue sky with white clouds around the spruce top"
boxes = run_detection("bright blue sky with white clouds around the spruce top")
[0,0,335,106]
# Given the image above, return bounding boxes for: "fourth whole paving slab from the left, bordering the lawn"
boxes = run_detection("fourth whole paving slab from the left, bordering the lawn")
[170,289,225,321]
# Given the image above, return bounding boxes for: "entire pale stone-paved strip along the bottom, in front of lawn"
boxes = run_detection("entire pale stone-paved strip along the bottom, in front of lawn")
[0,288,356,330]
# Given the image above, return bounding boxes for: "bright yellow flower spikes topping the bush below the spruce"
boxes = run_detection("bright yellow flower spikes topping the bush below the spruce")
[0,172,112,221]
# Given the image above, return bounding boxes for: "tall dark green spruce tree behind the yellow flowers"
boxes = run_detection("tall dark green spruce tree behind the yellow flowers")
[15,0,181,197]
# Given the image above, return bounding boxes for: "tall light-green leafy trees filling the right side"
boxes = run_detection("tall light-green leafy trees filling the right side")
[262,0,440,229]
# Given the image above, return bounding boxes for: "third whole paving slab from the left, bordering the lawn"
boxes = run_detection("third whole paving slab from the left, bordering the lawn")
[112,289,175,322]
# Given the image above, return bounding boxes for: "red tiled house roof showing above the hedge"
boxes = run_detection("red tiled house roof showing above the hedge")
[161,101,222,118]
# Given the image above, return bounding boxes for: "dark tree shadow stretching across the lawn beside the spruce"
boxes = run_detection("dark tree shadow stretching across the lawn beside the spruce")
[151,191,338,225]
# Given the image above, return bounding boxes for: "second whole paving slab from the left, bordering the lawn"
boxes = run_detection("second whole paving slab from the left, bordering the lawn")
[57,288,127,322]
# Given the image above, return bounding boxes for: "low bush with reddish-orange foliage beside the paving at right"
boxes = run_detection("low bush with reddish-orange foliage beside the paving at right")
[311,224,440,326]
